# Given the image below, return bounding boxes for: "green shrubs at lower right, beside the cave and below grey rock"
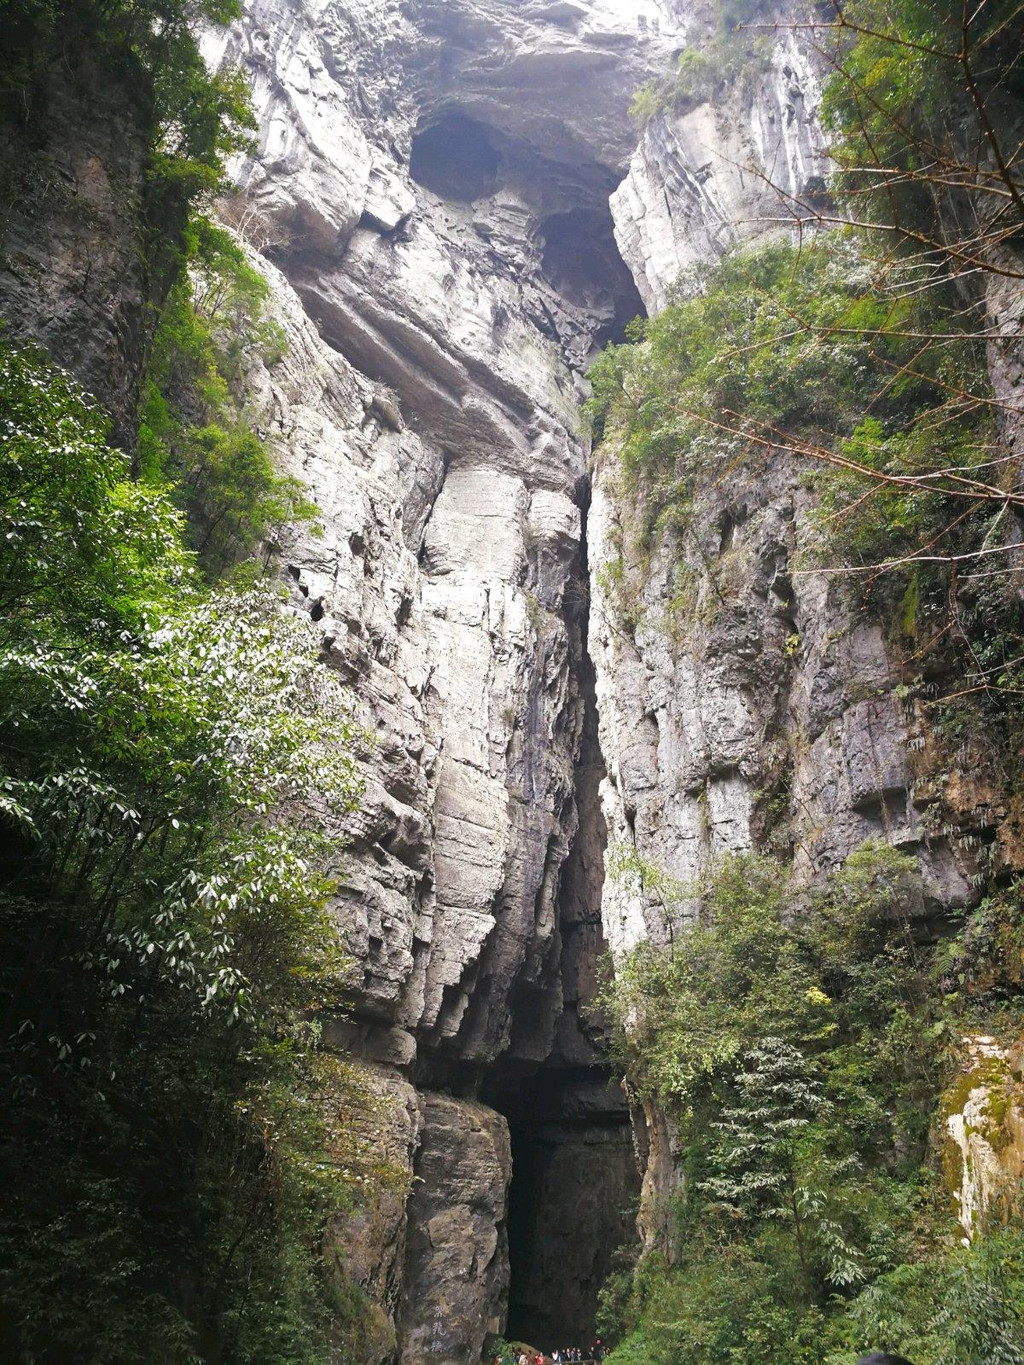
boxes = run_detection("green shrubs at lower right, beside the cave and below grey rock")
[602,845,1016,1365]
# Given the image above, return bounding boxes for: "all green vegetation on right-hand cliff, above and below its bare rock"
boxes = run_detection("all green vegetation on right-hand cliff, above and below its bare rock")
[591,0,1024,1365]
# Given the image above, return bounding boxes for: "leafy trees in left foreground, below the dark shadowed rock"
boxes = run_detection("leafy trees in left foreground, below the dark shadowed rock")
[0,335,366,1362]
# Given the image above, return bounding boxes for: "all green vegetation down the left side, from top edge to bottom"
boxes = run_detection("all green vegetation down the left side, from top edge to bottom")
[0,0,388,1365]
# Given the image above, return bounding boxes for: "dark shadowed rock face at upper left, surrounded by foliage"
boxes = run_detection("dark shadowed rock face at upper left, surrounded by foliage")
[0,45,152,444]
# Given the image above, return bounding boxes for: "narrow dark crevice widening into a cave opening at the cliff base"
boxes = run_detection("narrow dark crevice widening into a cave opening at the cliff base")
[481,491,640,1353]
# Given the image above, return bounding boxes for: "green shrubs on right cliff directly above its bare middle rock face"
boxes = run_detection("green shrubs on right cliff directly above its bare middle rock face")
[590,235,1024,737]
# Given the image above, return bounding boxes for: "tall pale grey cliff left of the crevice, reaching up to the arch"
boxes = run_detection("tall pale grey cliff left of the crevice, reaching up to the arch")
[209,0,693,1343]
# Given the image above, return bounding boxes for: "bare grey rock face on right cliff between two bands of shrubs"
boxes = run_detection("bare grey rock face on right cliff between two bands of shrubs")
[591,458,975,971]
